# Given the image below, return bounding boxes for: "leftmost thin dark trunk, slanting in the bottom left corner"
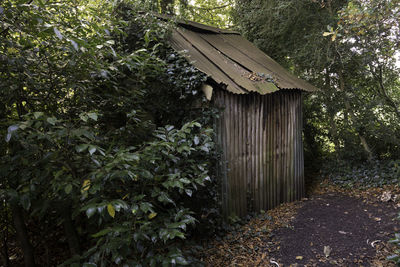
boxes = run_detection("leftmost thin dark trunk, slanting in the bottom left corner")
[10,204,35,267]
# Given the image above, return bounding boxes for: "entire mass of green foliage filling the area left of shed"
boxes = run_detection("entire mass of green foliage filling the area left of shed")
[0,0,218,266]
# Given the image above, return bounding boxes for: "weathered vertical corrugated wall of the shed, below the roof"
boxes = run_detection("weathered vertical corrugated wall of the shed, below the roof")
[214,90,304,219]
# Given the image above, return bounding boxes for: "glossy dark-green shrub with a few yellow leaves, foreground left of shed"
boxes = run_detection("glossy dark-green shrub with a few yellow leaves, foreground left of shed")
[6,113,213,265]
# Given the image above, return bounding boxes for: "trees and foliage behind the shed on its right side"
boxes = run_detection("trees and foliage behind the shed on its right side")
[236,0,400,165]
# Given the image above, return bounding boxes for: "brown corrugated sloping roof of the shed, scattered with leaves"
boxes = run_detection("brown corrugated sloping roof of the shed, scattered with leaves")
[171,21,318,95]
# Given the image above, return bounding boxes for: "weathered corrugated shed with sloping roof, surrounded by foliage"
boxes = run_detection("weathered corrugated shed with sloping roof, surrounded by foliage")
[167,18,317,216]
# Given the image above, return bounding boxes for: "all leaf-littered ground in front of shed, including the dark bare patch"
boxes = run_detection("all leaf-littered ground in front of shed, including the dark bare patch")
[198,181,400,267]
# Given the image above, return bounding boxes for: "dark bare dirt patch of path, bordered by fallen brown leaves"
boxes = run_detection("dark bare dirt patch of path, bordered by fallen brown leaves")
[271,193,399,266]
